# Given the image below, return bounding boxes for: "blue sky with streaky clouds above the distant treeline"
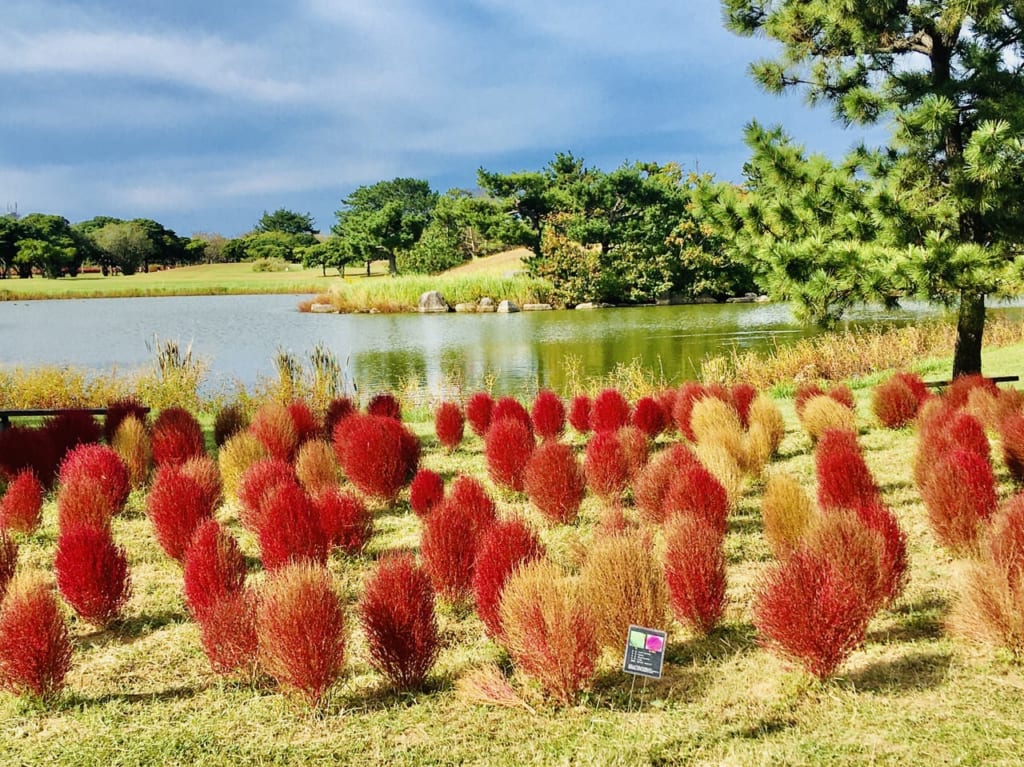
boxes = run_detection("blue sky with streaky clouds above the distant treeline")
[0,0,881,237]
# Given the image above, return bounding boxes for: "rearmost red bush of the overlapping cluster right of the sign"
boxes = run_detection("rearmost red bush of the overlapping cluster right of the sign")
[814,429,881,509]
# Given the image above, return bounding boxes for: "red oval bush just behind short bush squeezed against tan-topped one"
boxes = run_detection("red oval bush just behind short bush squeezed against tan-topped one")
[183,519,246,621]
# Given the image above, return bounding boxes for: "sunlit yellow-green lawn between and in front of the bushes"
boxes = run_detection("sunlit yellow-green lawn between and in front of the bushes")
[0,360,1024,767]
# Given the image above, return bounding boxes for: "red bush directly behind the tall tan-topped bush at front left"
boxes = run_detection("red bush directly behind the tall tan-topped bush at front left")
[256,481,330,570]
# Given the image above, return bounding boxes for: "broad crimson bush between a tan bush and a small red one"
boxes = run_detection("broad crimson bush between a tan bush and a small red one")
[335,414,420,502]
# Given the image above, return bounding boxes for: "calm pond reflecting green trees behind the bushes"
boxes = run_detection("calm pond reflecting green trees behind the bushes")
[0,296,1024,392]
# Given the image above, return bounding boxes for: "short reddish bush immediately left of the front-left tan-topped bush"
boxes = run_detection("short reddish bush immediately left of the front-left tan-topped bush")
[196,587,258,677]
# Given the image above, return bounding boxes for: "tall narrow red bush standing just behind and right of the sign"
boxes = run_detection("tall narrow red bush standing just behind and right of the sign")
[665,516,726,635]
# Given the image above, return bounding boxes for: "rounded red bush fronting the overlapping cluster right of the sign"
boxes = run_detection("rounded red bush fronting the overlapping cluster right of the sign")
[754,547,871,679]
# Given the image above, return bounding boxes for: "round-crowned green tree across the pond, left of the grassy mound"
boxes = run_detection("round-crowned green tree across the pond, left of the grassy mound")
[332,178,437,274]
